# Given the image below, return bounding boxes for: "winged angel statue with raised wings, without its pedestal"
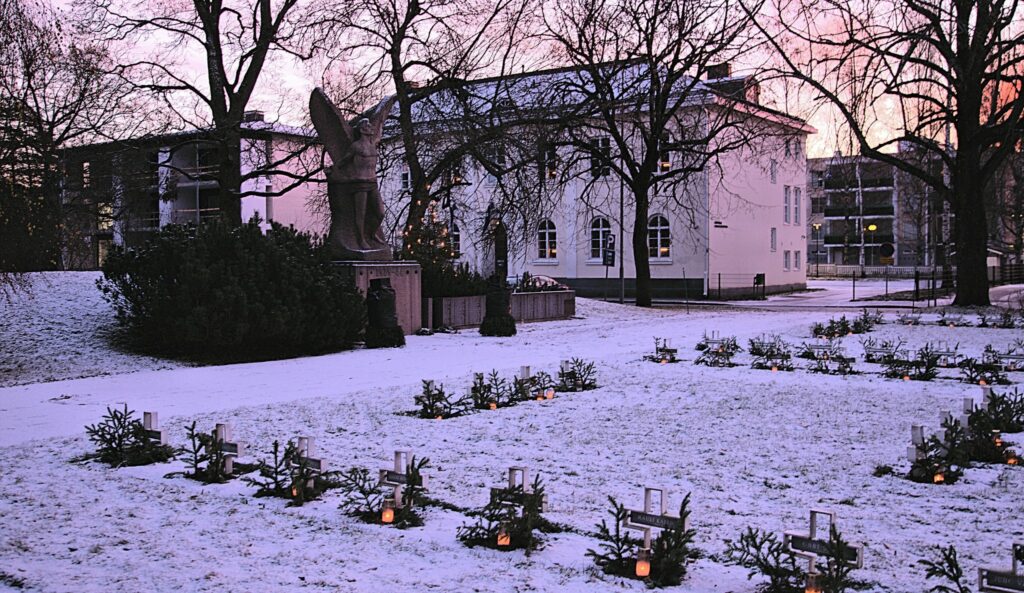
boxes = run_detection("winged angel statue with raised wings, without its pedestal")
[309,88,395,261]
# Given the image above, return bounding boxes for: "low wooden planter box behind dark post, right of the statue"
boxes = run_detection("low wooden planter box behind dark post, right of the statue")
[423,290,575,329]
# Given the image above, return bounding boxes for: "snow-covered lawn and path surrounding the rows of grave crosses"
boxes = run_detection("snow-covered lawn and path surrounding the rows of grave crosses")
[0,274,1024,593]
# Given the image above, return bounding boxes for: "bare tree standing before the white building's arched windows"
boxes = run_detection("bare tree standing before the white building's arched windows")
[546,0,767,306]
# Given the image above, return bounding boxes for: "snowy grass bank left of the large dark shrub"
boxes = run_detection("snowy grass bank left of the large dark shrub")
[0,271,187,387]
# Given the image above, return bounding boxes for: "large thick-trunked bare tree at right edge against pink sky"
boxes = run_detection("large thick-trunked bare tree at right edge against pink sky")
[751,0,1024,305]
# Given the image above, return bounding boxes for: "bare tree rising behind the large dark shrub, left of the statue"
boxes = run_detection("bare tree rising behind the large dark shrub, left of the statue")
[82,0,319,224]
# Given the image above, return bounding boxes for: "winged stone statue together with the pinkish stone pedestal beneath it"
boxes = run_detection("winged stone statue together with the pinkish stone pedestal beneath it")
[309,88,421,334]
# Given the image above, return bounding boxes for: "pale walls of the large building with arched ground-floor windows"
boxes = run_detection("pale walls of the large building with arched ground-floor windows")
[381,64,814,298]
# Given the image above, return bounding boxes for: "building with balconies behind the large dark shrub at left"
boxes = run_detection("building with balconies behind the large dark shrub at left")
[61,112,324,269]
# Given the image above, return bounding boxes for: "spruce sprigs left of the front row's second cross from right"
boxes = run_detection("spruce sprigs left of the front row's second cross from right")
[725,527,807,593]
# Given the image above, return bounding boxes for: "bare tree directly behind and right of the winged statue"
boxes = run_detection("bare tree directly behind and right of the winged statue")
[308,0,548,256]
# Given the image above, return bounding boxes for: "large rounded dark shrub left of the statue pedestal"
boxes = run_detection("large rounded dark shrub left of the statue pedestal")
[97,219,366,362]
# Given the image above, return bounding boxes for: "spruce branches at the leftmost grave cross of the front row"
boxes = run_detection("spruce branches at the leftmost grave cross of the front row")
[85,404,176,467]
